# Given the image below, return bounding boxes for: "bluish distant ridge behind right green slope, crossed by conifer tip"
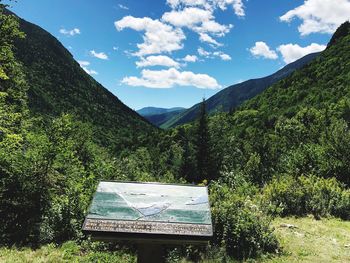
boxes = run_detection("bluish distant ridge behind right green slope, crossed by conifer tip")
[161,53,319,128]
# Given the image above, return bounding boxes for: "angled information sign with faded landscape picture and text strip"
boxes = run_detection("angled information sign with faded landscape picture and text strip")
[83,182,213,244]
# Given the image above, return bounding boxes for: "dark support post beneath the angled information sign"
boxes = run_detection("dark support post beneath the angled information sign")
[137,243,165,263]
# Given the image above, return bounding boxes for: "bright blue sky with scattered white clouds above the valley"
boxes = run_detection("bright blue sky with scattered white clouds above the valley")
[6,0,350,110]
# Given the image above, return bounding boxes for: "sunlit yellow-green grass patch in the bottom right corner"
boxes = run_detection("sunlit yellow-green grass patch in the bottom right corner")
[261,217,350,263]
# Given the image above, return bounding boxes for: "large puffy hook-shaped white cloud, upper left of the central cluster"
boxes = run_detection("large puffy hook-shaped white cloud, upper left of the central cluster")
[115,16,186,56]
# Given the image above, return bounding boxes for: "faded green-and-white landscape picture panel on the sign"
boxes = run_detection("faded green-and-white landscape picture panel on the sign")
[87,182,211,225]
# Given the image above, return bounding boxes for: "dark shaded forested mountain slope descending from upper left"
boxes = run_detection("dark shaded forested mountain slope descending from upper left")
[10,10,155,151]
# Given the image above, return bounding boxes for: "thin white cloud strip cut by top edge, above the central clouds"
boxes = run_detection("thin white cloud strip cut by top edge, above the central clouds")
[167,0,245,17]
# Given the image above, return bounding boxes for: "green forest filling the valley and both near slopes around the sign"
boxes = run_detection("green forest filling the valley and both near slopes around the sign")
[0,1,350,262]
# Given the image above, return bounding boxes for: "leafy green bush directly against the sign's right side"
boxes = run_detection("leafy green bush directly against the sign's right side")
[210,184,278,259]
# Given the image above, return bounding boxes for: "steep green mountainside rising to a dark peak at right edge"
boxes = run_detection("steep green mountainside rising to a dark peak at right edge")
[240,22,350,121]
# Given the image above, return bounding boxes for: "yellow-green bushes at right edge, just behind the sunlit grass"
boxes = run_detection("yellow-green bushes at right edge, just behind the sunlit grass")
[263,176,350,220]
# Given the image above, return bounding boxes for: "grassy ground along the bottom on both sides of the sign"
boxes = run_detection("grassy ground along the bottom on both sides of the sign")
[0,218,350,263]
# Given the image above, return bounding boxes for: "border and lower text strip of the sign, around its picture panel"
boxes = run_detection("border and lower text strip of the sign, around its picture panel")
[83,180,213,245]
